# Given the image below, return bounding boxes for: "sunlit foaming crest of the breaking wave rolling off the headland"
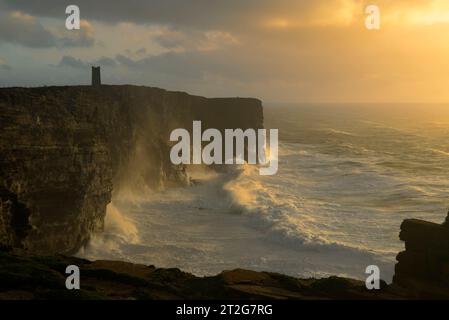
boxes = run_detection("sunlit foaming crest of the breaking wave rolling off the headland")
[220,162,373,256]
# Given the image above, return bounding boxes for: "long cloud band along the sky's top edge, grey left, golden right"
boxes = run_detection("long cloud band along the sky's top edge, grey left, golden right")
[6,0,449,33]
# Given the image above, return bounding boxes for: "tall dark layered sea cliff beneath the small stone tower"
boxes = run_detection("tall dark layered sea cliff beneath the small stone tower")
[0,86,263,254]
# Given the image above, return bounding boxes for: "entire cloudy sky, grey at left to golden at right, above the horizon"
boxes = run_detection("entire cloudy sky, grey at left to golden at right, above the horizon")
[0,0,449,103]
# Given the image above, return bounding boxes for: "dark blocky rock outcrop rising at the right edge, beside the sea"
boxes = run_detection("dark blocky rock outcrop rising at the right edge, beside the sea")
[393,214,449,299]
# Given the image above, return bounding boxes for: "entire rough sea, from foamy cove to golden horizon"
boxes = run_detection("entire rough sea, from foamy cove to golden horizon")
[79,104,449,281]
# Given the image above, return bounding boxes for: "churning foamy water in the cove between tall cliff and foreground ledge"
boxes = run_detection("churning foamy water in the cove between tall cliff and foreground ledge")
[79,158,392,278]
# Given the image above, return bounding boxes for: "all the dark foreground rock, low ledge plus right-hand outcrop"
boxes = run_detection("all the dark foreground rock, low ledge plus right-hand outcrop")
[0,212,449,300]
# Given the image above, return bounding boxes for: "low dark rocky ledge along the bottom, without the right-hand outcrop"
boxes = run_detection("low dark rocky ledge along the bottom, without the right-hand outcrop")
[0,252,400,300]
